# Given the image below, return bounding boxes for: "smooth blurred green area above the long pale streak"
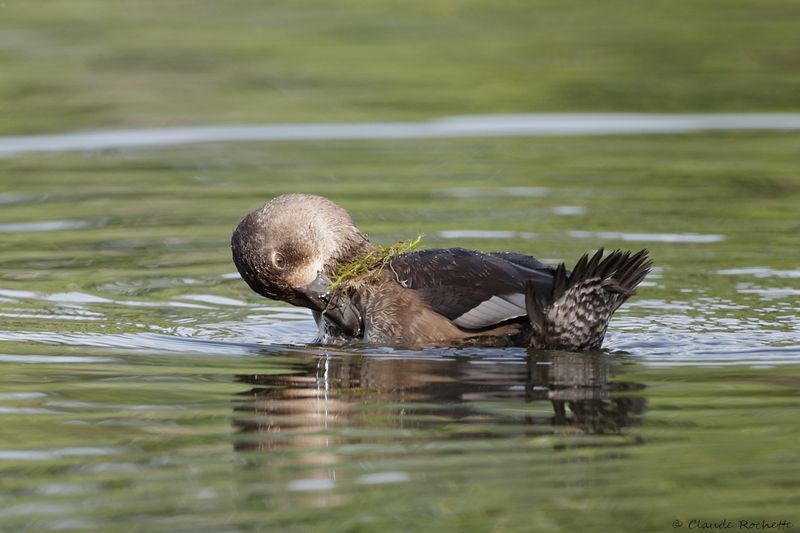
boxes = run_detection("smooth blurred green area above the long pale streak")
[0,0,800,135]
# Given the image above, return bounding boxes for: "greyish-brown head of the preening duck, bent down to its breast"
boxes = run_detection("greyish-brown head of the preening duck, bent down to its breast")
[231,194,372,311]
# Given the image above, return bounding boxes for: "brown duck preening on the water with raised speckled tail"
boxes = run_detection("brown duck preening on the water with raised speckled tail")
[231,193,652,351]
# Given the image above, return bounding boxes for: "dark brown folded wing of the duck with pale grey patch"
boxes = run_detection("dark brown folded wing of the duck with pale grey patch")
[391,248,555,330]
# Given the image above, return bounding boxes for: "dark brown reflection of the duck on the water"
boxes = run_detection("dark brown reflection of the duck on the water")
[235,352,645,454]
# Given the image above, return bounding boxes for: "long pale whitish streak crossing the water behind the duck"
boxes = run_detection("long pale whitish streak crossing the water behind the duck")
[0,113,800,157]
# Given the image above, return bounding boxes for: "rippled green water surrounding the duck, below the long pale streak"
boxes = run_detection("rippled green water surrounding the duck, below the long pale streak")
[0,134,800,531]
